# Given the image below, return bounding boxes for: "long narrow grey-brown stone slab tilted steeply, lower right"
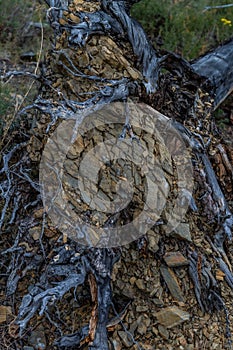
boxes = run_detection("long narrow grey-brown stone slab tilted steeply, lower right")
[160,266,185,302]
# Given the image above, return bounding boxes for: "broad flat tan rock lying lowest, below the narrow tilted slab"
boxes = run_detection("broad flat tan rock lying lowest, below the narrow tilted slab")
[155,306,190,328]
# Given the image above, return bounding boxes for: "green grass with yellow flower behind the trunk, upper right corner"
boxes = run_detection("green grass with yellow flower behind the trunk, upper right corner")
[131,0,233,60]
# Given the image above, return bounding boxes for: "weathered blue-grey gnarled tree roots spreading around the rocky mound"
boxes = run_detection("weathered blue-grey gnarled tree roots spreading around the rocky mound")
[0,0,233,350]
